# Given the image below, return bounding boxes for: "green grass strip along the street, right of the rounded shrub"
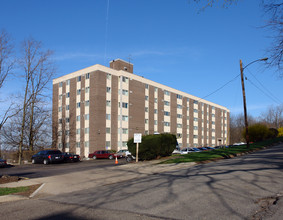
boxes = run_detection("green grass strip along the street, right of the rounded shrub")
[161,137,283,164]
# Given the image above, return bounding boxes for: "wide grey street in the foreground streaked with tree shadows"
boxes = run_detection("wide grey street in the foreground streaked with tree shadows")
[0,145,283,219]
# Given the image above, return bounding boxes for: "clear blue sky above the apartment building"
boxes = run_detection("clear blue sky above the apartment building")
[0,0,283,116]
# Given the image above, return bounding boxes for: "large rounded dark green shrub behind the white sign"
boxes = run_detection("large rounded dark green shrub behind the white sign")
[127,134,177,160]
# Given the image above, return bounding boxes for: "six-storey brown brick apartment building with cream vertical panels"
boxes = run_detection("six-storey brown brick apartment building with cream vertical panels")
[52,59,229,157]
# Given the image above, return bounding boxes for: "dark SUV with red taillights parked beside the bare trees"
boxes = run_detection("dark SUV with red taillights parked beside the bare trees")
[31,150,64,165]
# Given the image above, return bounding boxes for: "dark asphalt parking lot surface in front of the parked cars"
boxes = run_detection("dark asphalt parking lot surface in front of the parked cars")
[0,158,126,178]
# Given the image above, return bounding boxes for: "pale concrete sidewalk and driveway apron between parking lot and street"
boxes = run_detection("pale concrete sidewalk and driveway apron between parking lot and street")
[0,160,195,203]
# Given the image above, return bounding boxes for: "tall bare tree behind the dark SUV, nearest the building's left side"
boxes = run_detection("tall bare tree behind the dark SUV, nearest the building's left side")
[19,38,55,163]
